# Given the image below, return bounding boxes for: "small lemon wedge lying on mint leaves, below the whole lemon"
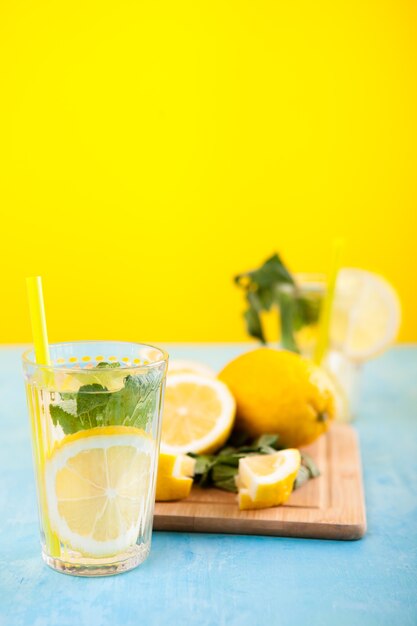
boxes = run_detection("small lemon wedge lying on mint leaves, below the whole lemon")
[236,448,301,510]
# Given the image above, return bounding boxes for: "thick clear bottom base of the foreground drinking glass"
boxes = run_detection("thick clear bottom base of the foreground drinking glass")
[42,542,150,576]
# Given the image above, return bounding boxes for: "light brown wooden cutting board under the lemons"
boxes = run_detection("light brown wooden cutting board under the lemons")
[154,424,366,540]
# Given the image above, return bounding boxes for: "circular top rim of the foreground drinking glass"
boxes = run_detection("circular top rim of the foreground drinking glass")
[22,339,169,375]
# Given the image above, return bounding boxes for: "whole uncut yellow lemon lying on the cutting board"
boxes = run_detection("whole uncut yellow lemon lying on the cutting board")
[219,348,335,448]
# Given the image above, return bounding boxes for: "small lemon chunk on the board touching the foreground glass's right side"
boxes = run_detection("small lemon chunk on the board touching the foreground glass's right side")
[156,452,195,502]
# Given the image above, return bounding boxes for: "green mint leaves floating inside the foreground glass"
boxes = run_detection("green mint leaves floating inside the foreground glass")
[49,362,161,435]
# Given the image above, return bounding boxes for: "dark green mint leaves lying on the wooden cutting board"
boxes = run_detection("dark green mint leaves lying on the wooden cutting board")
[189,435,320,493]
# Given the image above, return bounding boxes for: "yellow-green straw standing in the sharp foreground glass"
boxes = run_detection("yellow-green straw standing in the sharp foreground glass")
[26,276,61,556]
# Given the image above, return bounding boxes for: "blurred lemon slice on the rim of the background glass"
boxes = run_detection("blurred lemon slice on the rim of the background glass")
[330,269,401,362]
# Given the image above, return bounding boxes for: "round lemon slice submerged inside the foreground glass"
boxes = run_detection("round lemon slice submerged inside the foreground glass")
[45,426,154,557]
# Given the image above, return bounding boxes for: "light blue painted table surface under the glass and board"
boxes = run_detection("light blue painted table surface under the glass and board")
[0,344,417,626]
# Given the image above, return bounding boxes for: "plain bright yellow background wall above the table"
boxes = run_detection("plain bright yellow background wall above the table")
[0,0,417,342]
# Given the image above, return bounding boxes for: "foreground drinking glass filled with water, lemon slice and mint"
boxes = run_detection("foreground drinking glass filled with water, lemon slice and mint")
[23,341,168,576]
